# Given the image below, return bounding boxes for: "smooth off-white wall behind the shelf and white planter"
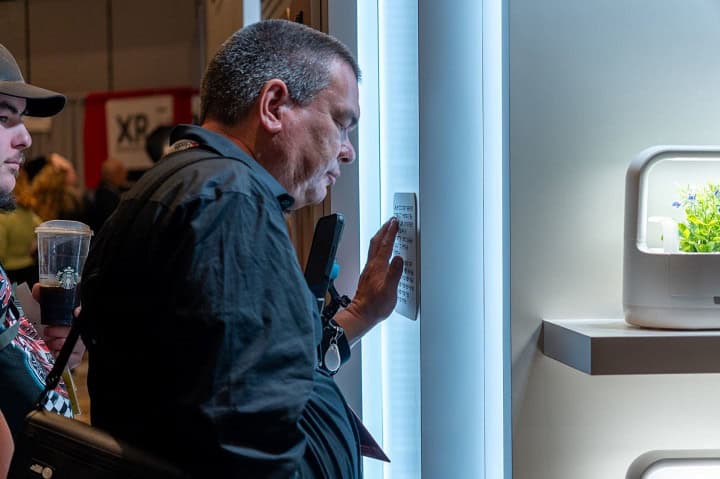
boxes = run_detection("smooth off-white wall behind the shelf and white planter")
[509,0,720,479]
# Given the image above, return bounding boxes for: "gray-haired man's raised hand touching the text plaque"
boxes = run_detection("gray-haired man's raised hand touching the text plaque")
[335,218,403,344]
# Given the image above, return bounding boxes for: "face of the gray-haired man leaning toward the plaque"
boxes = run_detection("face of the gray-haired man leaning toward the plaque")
[280,61,360,208]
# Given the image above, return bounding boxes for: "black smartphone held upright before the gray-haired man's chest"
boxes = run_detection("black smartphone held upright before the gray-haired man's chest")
[305,213,345,300]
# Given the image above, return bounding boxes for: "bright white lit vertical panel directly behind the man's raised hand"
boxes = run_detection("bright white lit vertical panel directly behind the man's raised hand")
[376,0,422,479]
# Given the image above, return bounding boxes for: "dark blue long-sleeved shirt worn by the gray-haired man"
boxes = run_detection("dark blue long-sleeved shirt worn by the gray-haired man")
[82,126,361,479]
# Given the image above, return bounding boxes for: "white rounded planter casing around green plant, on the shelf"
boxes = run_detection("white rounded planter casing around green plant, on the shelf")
[623,146,720,329]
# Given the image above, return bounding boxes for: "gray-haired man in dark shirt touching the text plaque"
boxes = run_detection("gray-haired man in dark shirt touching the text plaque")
[81,20,403,479]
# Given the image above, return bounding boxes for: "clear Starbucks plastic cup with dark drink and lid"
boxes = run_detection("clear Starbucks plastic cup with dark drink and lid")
[35,220,93,326]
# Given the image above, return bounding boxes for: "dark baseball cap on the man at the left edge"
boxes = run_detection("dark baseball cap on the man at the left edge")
[0,44,65,116]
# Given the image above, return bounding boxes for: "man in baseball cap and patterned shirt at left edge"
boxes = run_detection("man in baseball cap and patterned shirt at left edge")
[0,45,82,458]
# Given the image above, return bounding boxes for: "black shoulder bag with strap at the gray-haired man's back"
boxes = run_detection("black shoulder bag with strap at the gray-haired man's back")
[8,320,189,479]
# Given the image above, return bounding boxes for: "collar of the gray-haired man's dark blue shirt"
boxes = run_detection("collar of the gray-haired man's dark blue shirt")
[170,125,295,211]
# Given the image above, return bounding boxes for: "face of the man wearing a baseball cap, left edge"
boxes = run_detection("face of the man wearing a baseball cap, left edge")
[0,94,32,197]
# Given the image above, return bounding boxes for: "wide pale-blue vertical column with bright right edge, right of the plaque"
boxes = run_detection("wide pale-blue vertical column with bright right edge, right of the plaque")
[418,0,509,479]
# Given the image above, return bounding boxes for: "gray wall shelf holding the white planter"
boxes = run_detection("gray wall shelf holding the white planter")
[541,319,720,374]
